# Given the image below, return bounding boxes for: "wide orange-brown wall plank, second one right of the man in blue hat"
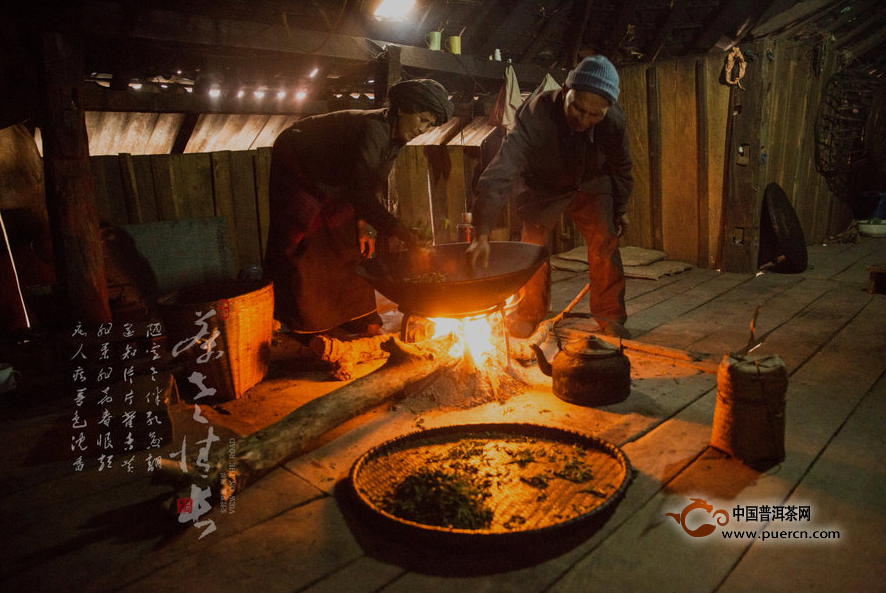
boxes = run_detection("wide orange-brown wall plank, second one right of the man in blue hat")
[658,59,699,264]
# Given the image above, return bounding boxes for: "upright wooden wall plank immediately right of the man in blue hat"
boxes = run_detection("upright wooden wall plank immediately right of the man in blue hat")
[620,64,655,249]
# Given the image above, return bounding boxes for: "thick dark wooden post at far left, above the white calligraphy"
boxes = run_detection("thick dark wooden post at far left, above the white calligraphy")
[43,32,111,325]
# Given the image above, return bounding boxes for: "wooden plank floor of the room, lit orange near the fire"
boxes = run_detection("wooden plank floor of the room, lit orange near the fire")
[0,237,886,593]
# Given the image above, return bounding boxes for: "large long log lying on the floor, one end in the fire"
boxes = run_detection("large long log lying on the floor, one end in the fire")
[155,336,459,501]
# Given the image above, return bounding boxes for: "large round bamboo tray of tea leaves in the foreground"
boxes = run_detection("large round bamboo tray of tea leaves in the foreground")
[350,424,632,545]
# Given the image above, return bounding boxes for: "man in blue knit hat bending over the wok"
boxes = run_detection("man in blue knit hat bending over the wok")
[468,56,633,338]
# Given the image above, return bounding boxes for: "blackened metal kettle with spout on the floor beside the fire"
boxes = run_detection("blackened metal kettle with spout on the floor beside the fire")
[532,336,631,406]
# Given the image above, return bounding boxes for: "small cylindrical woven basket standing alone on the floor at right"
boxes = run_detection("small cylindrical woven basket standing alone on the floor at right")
[711,355,788,466]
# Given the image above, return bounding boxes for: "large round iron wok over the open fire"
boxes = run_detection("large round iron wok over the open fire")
[357,241,548,317]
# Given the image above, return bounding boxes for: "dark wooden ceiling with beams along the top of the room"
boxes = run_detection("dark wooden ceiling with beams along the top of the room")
[6,0,886,123]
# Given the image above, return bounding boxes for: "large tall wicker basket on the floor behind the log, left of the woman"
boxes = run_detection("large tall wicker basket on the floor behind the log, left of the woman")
[159,280,274,399]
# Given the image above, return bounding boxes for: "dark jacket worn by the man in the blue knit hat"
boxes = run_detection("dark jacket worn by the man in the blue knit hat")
[473,89,634,234]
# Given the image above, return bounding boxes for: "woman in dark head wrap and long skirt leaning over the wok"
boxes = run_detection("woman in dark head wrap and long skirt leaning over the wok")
[265,79,453,334]
